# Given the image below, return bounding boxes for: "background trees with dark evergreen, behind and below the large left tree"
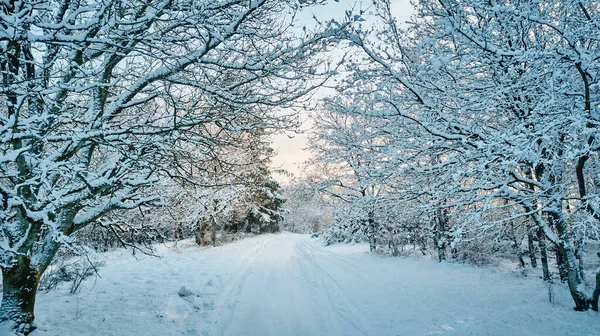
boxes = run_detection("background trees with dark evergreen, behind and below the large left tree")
[75,134,286,253]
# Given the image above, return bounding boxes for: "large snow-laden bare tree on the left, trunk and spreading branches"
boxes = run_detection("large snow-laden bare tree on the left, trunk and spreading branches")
[0,0,352,334]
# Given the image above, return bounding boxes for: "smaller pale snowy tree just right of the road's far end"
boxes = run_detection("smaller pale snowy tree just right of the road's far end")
[309,106,396,251]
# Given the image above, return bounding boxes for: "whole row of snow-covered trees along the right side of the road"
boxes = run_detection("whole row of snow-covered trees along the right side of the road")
[309,0,600,310]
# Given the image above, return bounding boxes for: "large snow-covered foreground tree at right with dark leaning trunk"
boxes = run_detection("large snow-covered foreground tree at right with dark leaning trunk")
[314,0,600,310]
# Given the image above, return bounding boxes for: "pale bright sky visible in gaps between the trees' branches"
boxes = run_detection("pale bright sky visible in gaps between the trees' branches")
[272,0,412,183]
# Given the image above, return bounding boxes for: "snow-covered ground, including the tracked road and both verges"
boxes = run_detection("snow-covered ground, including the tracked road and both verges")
[34,234,600,336]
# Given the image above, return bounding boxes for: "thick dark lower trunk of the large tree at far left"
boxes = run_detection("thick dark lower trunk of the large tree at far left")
[0,255,42,335]
